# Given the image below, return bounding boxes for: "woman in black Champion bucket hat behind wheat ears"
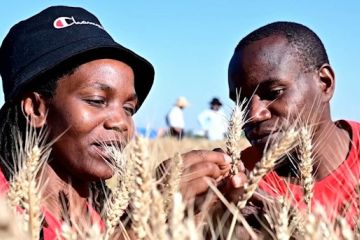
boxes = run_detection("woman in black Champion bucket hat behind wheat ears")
[0,6,154,239]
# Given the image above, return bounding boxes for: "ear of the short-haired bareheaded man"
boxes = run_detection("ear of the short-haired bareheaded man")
[318,63,335,102]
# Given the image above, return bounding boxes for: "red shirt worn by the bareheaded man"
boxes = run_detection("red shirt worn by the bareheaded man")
[242,120,360,226]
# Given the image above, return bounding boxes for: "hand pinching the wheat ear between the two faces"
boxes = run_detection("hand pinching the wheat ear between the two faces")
[180,149,247,214]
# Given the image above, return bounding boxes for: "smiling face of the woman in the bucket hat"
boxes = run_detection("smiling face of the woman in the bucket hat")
[46,59,137,180]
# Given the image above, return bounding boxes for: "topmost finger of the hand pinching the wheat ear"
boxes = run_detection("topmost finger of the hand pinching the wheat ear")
[182,150,231,168]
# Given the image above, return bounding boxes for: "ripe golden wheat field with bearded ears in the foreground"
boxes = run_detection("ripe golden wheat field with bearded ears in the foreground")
[0,105,360,240]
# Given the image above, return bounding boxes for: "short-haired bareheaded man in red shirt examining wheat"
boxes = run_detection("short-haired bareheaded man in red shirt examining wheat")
[229,22,360,225]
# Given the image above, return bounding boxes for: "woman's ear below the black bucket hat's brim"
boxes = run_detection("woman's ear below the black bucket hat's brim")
[21,92,48,128]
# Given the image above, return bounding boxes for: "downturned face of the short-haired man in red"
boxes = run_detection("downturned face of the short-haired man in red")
[229,36,319,151]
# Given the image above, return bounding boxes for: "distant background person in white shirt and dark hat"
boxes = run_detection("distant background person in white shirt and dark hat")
[198,98,227,140]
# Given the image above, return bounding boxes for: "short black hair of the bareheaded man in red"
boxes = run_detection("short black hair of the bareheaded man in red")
[235,22,329,72]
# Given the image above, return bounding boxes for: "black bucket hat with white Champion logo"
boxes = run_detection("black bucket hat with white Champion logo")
[0,6,154,107]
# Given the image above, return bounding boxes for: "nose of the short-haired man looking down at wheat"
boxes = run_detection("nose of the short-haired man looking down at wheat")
[248,95,271,123]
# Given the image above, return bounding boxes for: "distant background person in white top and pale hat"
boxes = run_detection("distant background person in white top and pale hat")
[166,97,189,139]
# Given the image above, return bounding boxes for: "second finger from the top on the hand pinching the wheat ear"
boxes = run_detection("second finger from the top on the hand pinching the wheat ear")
[181,162,230,182]
